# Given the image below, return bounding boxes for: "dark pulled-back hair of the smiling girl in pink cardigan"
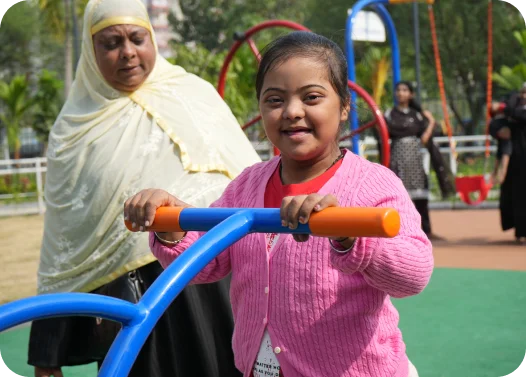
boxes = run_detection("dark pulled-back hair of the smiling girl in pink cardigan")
[256,31,350,109]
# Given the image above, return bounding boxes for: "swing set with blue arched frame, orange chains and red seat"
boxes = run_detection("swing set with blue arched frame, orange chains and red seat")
[345,0,493,205]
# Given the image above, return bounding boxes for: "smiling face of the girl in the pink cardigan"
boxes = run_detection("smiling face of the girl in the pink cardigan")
[259,57,350,161]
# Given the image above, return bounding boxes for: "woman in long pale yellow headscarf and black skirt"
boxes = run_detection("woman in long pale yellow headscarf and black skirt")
[29,0,260,377]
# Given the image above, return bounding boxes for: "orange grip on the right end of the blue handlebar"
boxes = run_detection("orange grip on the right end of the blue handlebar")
[309,207,400,237]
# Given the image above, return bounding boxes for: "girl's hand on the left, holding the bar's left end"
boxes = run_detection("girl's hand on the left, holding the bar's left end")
[124,189,190,232]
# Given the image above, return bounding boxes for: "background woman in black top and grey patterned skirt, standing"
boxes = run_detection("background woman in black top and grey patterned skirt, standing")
[384,81,454,240]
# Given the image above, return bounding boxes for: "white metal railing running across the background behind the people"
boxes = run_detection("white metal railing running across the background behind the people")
[0,135,496,216]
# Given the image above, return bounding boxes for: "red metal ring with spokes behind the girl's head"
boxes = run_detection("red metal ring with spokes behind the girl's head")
[217,20,390,166]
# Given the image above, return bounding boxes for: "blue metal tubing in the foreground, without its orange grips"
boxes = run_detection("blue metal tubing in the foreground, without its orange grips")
[0,208,338,377]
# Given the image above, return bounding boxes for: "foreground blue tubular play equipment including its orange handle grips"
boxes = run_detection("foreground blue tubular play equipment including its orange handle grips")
[0,207,400,377]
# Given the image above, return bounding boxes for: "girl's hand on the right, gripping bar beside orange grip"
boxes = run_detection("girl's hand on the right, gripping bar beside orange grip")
[281,194,339,242]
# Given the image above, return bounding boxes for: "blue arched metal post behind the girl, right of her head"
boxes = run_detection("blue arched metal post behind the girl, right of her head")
[345,0,402,154]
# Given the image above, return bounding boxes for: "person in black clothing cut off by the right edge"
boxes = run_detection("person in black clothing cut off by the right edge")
[492,83,526,244]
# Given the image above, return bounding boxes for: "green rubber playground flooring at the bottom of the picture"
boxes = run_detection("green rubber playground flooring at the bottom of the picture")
[0,268,526,377]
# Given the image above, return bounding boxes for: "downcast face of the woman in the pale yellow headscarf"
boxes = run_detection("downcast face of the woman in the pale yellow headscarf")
[93,25,156,92]
